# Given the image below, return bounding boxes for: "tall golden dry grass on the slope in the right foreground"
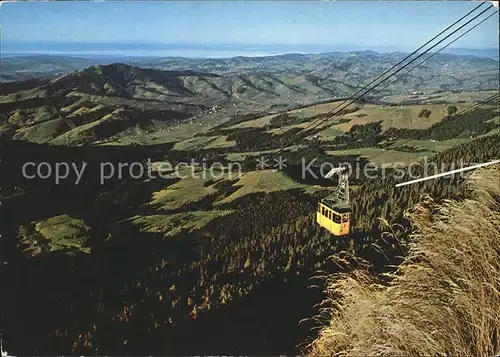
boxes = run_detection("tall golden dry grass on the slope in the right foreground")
[308,167,500,356]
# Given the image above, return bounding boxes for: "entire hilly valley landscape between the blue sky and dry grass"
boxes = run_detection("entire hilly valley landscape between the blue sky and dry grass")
[0,51,500,355]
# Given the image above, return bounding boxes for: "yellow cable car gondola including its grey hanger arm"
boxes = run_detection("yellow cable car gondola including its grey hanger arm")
[316,167,351,236]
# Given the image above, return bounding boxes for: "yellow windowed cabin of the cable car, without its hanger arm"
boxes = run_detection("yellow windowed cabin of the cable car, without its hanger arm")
[316,199,351,236]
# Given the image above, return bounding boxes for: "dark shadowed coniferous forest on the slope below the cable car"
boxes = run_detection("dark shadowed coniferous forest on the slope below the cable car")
[2,131,499,354]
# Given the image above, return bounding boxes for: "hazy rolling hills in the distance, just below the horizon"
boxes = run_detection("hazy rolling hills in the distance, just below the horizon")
[0,51,498,145]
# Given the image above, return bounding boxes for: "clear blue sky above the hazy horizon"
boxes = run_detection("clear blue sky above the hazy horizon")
[0,1,498,55]
